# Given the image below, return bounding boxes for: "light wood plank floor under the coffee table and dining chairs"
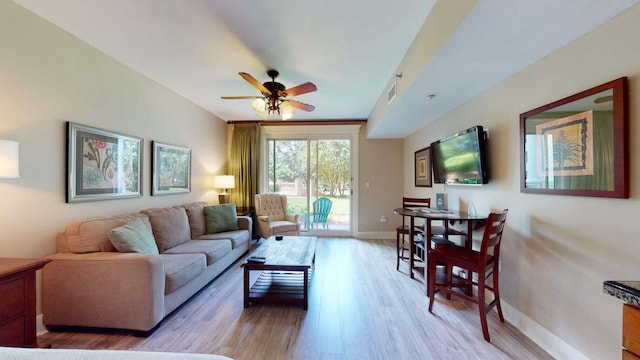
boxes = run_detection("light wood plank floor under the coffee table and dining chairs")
[39,238,552,360]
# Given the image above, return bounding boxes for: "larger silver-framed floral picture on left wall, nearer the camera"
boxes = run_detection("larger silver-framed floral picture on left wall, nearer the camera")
[66,122,142,203]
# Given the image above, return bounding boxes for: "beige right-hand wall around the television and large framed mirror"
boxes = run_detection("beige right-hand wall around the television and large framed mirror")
[404,5,640,359]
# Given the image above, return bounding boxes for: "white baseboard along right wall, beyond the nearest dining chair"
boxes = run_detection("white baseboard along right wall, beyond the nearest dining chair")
[500,300,589,360]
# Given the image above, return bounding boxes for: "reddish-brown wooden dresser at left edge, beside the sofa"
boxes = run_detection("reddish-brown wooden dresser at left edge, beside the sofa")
[0,258,49,347]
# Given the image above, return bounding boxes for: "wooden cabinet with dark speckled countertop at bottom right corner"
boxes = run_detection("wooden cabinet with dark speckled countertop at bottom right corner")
[603,281,640,360]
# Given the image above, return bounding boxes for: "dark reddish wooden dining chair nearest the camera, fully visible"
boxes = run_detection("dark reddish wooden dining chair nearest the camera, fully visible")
[427,209,508,342]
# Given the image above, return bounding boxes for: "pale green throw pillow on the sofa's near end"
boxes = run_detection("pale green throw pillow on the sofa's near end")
[109,218,159,254]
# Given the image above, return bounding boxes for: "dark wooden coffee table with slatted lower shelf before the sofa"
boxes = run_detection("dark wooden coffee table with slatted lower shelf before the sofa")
[242,236,316,310]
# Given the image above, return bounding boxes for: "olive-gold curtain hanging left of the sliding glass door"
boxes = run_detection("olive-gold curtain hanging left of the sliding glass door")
[229,123,260,210]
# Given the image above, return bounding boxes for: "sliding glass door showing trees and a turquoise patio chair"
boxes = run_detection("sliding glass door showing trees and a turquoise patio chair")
[264,129,353,235]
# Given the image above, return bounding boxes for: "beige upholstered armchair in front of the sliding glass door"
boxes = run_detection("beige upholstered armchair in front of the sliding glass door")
[255,193,300,239]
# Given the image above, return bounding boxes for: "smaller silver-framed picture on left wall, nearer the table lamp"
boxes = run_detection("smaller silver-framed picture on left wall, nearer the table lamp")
[151,141,191,195]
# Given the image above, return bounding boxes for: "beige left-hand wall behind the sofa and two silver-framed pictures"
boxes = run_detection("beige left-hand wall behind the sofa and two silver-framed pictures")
[0,1,227,257]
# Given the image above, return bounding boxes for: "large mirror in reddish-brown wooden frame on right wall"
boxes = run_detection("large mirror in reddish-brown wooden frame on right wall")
[520,77,629,199]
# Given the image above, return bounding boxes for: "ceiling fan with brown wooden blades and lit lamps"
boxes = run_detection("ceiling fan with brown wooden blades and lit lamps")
[222,69,318,120]
